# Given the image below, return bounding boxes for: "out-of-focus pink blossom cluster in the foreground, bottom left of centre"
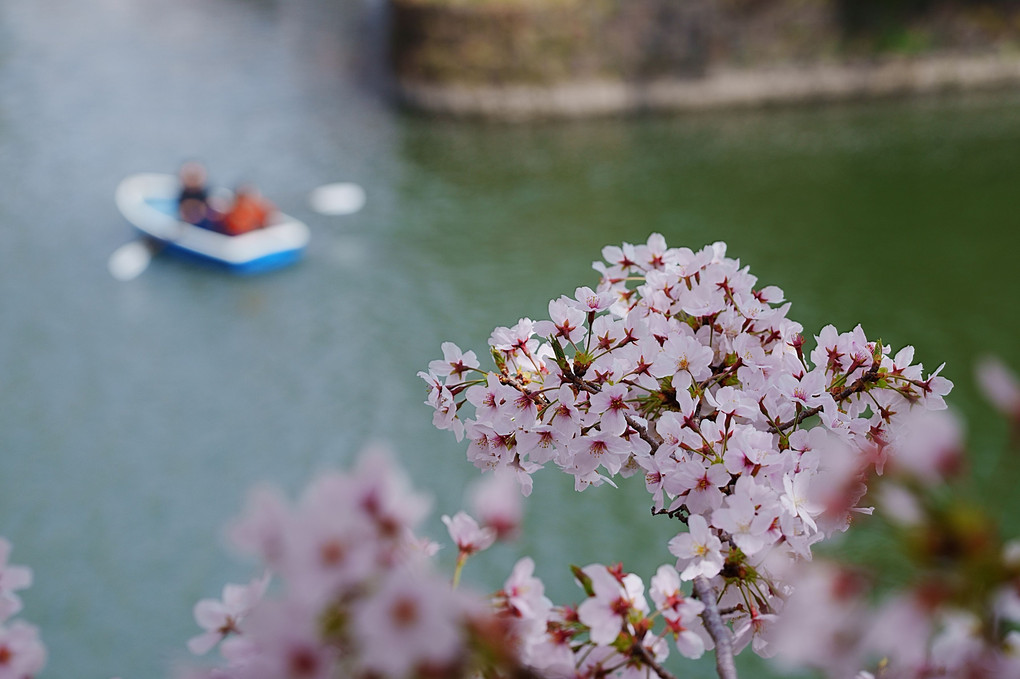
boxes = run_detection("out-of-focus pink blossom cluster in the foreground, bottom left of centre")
[179,444,554,679]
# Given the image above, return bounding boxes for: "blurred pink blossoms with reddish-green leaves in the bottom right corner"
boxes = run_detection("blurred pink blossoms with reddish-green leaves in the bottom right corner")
[774,375,1020,679]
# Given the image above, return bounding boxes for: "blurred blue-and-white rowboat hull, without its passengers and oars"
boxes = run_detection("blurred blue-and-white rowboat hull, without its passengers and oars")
[115,173,310,273]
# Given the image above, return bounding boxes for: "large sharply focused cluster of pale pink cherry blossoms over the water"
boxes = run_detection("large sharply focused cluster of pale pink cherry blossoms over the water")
[420,234,952,660]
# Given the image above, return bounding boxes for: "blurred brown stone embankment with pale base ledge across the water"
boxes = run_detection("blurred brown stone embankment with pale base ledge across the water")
[390,0,1020,119]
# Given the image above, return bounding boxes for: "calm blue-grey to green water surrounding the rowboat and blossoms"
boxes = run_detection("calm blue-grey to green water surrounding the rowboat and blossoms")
[0,0,1020,679]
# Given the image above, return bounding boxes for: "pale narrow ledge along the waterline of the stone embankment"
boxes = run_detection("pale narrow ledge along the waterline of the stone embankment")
[397,56,1020,120]
